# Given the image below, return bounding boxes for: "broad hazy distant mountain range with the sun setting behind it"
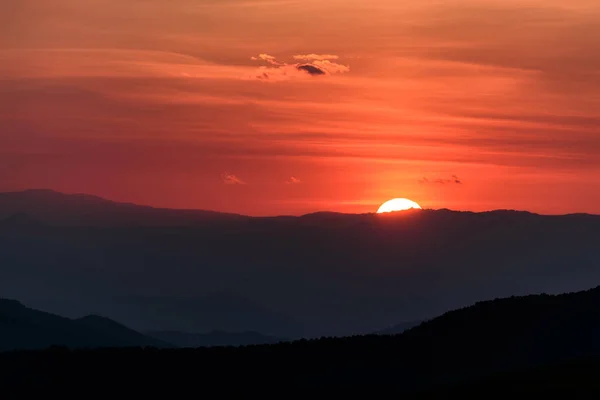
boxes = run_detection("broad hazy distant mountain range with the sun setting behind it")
[0,191,600,338]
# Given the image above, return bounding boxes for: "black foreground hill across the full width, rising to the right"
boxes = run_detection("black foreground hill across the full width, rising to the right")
[0,288,600,398]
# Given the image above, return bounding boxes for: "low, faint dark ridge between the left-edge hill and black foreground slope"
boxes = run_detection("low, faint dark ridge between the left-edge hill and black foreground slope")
[146,331,289,347]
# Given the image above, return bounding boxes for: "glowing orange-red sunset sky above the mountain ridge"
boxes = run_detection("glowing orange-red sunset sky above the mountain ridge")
[0,0,600,215]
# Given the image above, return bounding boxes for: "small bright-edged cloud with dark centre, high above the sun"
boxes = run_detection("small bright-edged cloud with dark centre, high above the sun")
[250,53,350,81]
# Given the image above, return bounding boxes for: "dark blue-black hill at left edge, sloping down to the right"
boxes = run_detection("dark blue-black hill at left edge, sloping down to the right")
[0,299,172,351]
